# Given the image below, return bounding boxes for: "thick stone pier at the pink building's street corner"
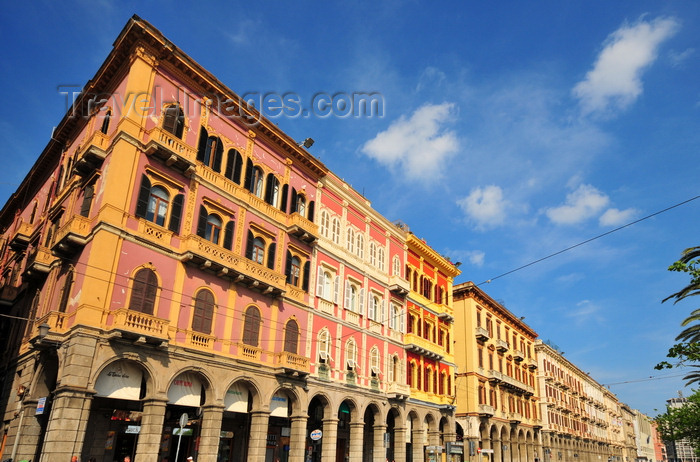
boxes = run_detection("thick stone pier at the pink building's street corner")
[40,387,92,462]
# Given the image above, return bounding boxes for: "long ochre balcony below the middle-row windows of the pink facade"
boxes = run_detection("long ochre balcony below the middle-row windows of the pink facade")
[180,235,286,297]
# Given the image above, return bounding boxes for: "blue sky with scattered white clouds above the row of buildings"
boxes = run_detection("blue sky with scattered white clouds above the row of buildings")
[0,0,700,415]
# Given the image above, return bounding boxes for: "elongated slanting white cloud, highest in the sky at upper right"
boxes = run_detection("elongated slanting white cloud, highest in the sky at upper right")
[573,18,678,114]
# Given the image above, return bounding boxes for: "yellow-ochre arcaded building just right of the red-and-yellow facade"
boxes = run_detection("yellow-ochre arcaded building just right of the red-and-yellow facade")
[454,282,542,462]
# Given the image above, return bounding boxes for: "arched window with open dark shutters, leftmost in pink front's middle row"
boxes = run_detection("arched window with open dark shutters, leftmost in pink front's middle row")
[136,175,185,233]
